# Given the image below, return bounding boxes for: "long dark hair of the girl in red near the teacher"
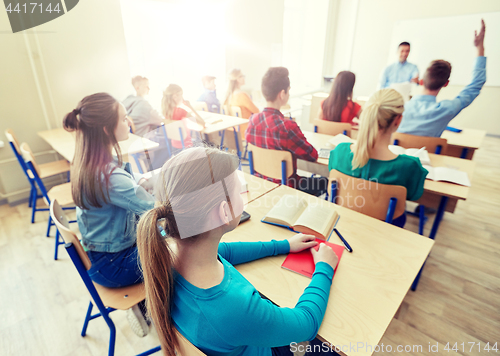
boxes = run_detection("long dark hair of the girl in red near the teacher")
[322,71,356,122]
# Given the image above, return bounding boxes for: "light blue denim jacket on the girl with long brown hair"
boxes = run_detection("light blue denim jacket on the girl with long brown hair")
[76,161,154,252]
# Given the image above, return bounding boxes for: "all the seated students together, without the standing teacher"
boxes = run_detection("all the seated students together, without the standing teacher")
[60,23,485,356]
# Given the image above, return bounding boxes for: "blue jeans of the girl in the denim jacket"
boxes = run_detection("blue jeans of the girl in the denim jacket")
[87,245,143,288]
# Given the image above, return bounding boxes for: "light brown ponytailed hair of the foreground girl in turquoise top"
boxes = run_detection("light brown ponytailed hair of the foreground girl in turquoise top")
[137,147,239,356]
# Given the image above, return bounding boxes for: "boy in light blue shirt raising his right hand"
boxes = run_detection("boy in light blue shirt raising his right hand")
[398,20,486,137]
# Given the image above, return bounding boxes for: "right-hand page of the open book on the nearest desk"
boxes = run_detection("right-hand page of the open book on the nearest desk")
[294,206,338,240]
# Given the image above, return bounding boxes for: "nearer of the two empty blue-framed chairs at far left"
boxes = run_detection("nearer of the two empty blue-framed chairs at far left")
[20,143,76,260]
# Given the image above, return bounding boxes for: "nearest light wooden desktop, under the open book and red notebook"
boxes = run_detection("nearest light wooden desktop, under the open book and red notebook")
[222,186,434,356]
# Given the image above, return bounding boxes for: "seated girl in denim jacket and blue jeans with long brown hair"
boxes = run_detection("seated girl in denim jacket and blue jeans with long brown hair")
[64,93,154,336]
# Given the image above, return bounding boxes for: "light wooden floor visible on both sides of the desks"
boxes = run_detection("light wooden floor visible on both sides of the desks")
[0,137,500,356]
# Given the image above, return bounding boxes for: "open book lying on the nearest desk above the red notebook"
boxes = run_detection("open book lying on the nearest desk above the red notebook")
[262,195,340,240]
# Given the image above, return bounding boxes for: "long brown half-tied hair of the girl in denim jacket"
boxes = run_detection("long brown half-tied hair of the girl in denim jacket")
[63,93,122,209]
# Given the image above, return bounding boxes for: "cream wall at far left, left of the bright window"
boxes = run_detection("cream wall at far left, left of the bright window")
[0,0,130,202]
